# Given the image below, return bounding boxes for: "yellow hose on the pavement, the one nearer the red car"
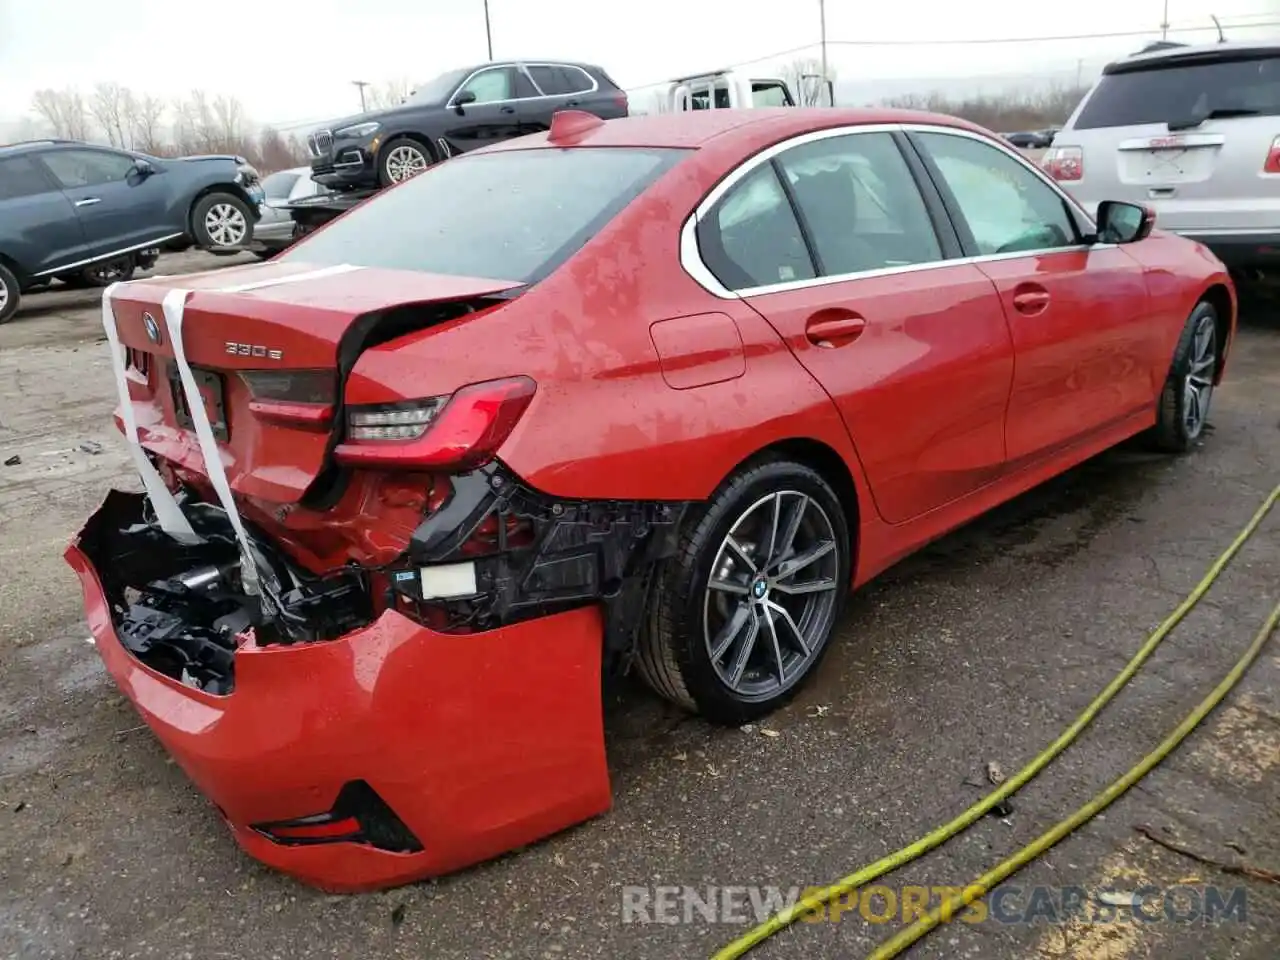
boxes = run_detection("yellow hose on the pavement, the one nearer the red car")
[712,485,1280,960]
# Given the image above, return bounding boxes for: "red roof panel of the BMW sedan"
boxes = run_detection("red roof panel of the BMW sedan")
[475,106,989,154]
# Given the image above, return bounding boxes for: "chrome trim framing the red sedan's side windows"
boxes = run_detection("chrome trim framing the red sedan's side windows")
[680,123,1116,300]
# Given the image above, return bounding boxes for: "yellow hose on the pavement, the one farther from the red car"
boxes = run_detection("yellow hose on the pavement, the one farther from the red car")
[867,603,1280,960]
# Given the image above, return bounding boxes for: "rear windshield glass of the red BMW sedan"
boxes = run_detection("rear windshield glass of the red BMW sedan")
[278,147,686,283]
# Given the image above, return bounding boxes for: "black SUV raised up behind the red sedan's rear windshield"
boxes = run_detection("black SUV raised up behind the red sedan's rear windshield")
[307,60,627,191]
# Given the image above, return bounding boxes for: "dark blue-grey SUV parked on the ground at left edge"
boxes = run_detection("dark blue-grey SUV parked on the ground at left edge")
[0,140,262,323]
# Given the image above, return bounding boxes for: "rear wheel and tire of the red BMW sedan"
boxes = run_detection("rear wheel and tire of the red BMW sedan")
[637,460,852,724]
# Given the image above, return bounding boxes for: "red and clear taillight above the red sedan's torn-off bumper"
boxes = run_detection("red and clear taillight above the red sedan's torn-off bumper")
[334,376,536,470]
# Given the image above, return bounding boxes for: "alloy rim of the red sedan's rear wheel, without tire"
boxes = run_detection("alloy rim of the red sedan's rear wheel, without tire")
[703,490,840,700]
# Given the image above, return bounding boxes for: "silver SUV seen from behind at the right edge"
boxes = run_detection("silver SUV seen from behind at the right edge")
[1041,42,1280,289]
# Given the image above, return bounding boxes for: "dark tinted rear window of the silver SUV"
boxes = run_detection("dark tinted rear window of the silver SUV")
[1073,55,1280,131]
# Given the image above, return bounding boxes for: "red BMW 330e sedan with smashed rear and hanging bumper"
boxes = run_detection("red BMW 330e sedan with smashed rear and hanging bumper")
[67,109,1235,890]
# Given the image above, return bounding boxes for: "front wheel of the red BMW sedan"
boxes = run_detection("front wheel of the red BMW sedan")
[1151,301,1219,453]
